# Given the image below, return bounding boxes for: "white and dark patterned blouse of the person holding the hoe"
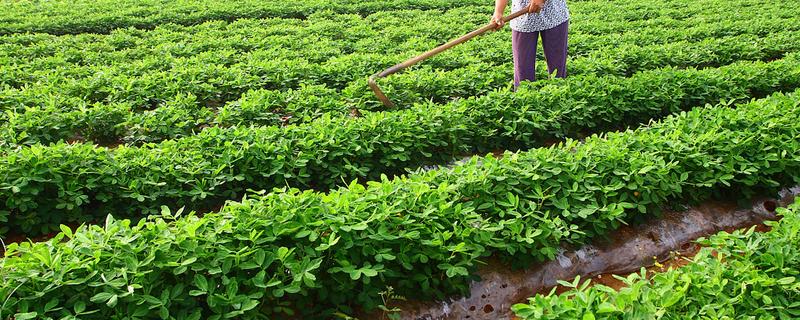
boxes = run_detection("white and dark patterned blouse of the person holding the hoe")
[511,0,569,32]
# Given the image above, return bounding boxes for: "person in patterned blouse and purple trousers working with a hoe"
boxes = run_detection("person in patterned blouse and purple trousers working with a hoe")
[491,0,569,88]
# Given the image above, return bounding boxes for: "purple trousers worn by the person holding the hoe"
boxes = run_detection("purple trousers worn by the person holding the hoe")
[511,21,569,87]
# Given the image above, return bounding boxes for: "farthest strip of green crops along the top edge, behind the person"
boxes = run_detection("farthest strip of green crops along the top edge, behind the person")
[0,0,764,35]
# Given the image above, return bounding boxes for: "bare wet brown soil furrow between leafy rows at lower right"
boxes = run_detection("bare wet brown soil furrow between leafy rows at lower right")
[376,187,800,320]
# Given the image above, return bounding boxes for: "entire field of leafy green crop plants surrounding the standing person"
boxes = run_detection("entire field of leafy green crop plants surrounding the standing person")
[0,0,800,320]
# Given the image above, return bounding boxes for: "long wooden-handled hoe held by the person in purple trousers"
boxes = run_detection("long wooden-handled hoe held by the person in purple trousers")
[369,8,528,107]
